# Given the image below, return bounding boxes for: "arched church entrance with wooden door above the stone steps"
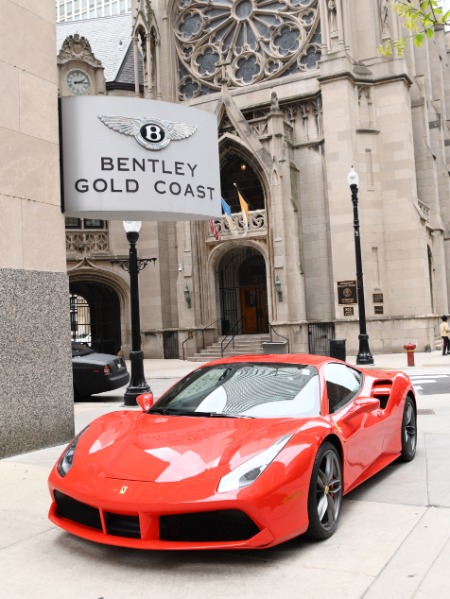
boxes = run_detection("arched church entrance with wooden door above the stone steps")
[219,246,269,335]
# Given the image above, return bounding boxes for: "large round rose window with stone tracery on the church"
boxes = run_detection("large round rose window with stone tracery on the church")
[175,0,321,99]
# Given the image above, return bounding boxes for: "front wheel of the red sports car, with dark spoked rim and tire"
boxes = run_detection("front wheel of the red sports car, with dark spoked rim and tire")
[306,442,343,541]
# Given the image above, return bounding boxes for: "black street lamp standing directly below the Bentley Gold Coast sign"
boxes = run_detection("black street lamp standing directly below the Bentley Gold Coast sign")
[123,221,150,406]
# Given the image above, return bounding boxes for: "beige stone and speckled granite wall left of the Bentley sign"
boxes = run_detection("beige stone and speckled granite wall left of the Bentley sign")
[0,0,74,457]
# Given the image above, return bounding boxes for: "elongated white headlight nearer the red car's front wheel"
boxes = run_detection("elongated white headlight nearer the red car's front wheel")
[217,435,292,493]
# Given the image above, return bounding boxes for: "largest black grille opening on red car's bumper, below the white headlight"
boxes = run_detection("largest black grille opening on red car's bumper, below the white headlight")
[159,510,260,543]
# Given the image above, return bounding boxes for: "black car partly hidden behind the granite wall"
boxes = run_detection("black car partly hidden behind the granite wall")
[72,342,130,399]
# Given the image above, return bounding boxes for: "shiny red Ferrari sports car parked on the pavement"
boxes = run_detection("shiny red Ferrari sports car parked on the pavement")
[49,354,417,549]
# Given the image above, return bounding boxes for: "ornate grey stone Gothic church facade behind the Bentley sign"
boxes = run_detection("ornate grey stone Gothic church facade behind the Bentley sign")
[58,0,450,357]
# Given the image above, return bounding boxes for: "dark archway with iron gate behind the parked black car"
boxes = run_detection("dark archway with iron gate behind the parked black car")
[69,281,121,354]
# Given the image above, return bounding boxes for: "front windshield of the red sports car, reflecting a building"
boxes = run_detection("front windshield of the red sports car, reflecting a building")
[149,363,320,418]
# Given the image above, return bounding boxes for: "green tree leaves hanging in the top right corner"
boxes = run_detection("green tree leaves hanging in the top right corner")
[378,0,450,56]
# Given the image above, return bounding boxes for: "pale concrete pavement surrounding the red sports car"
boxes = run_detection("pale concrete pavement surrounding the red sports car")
[0,351,450,599]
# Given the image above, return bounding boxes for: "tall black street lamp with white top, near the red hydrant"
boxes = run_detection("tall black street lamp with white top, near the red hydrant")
[347,166,373,364]
